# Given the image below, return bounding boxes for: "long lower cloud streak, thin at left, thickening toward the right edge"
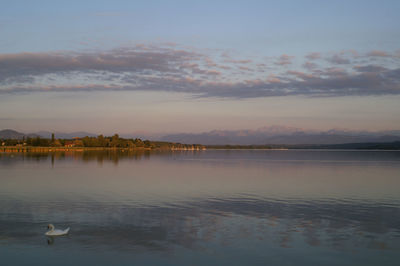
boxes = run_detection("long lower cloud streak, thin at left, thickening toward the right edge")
[3,69,400,98]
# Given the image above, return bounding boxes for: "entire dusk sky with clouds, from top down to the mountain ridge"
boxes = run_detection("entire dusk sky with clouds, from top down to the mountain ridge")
[0,0,400,134]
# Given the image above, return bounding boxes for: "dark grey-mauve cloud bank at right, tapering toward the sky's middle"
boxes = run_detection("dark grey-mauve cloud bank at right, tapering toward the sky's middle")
[200,68,400,98]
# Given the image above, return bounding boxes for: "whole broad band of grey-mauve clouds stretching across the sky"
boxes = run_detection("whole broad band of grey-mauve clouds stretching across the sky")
[0,45,400,98]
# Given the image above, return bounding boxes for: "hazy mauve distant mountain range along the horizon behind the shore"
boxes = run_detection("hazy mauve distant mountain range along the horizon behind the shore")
[0,126,400,145]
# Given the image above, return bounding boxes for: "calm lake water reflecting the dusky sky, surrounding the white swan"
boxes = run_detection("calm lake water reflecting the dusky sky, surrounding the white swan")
[0,150,400,265]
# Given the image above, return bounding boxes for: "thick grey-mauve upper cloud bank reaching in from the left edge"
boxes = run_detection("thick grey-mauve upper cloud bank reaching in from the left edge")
[0,50,196,82]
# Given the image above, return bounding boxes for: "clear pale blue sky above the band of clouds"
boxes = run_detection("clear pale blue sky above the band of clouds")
[0,1,400,55]
